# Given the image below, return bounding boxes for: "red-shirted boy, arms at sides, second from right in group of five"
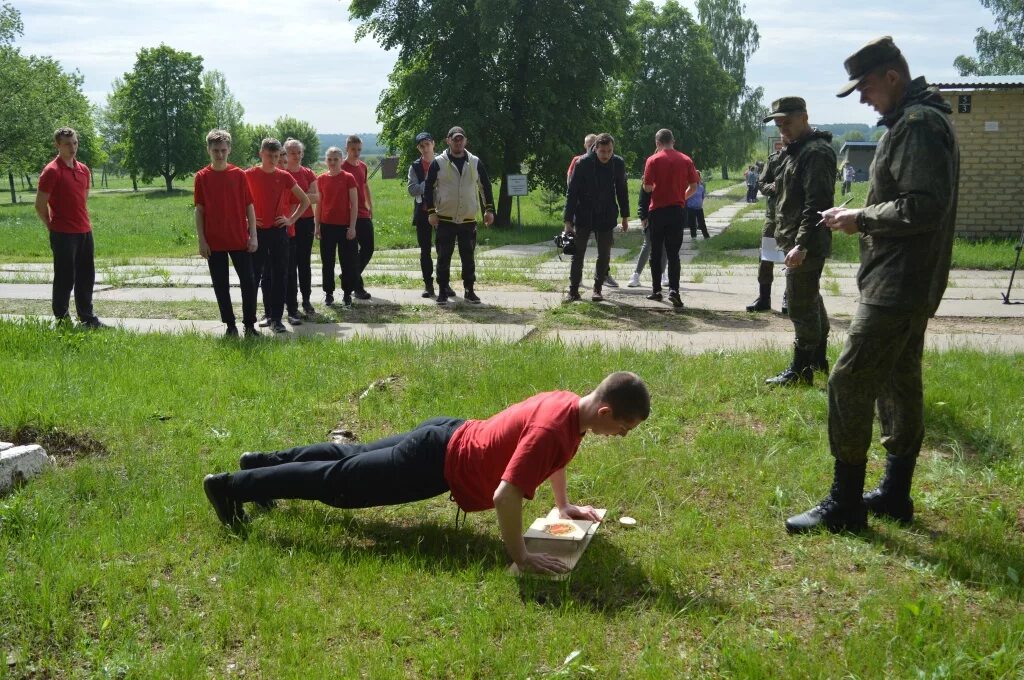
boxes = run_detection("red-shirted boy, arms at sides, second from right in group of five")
[313,146,359,306]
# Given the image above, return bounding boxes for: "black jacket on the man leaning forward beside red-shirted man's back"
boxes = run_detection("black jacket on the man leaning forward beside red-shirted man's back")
[563,151,630,231]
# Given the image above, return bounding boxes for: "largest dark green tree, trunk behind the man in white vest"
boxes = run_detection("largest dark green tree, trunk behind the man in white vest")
[349,0,635,225]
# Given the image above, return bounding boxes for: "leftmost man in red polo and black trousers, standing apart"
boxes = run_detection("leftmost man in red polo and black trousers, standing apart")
[36,127,103,329]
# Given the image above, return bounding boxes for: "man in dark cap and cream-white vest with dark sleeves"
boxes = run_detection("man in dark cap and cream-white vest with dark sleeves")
[423,126,495,304]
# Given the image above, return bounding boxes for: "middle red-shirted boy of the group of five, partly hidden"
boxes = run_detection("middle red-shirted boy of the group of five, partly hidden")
[285,138,316,319]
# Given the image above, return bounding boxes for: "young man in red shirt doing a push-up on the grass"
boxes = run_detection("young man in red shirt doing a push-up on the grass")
[203,372,650,573]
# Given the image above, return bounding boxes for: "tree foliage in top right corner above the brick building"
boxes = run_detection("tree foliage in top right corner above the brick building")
[953,0,1024,76]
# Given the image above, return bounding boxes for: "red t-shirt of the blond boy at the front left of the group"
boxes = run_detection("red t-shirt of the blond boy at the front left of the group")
[193,165,253,252]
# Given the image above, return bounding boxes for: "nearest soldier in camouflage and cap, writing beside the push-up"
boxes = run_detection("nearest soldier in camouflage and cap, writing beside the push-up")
[785,37,959,533]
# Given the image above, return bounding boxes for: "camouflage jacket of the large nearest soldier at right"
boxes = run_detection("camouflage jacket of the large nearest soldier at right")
[857,78,959,316]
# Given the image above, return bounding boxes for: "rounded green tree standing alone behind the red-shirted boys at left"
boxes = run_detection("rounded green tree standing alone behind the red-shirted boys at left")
[124,45,212,192]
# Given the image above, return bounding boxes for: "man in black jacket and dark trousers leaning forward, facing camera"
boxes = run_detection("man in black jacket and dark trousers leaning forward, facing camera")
[563,132,630,302]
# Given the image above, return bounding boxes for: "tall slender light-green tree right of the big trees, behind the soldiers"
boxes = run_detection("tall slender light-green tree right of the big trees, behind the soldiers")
[696,0,764,179]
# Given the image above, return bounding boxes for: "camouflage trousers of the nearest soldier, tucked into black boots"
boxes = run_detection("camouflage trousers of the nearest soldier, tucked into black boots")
[828,304,928,464]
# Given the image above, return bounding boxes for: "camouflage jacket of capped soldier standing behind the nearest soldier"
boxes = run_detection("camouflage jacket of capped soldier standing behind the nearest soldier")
[775,129,837,258]
